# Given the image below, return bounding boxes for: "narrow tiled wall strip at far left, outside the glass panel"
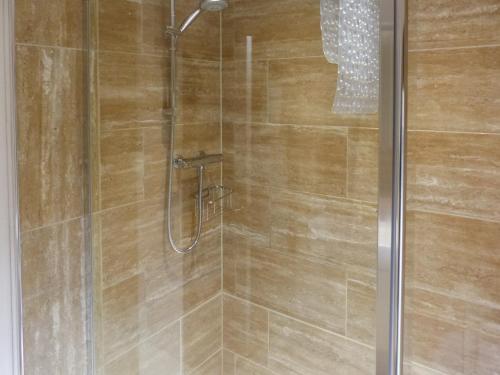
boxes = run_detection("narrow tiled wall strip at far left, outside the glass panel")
[15,0,87,375]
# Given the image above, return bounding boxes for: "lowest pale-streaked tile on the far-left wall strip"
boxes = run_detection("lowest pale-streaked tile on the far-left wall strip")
[21,219,87,375]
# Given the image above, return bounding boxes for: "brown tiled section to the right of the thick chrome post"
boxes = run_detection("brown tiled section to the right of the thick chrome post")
[405,1,500,374]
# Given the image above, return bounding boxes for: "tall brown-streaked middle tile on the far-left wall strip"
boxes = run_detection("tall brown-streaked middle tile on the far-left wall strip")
[16,46,83,230]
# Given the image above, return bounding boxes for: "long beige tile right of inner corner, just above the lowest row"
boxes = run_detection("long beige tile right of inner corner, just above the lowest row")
[224,230,346,334]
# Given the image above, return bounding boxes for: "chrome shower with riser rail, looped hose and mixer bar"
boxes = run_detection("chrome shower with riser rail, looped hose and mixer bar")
[166,0,228,254]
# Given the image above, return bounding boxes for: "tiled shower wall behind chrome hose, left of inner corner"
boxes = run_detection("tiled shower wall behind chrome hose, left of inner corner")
[92,0,222,375]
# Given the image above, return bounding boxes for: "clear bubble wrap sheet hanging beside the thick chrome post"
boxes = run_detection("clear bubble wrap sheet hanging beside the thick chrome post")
[321,0,380,114]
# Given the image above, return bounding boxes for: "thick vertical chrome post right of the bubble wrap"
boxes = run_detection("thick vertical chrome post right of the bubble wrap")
[376,0,407,375]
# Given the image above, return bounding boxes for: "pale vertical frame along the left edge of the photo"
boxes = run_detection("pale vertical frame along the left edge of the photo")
[0,0,22,375]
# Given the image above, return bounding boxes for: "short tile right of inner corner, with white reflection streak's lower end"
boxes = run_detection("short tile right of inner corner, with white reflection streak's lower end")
[222,60,268,125]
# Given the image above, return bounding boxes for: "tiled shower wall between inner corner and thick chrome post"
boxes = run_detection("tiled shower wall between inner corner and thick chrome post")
[222,0,378,375]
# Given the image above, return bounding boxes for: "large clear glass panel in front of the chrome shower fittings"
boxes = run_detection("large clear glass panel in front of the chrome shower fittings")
[90,0,378,375]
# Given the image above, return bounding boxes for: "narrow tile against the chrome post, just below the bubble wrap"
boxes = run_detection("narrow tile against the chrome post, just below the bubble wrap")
[347,128,378,202]
